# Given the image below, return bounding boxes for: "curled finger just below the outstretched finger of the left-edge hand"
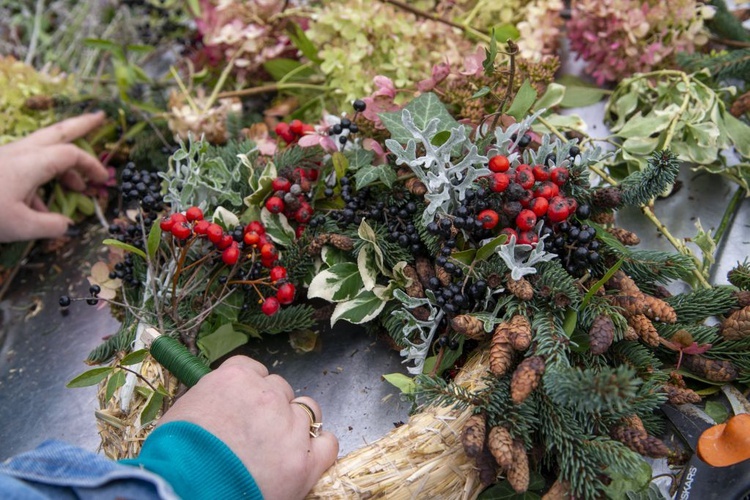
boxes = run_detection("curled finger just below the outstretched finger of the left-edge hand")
[26,144,109,184]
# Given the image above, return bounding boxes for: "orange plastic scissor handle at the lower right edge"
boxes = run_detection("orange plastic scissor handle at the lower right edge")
[698,413,750,467]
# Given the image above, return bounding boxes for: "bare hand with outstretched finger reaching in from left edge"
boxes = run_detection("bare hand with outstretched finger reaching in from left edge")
[0,112,109,242]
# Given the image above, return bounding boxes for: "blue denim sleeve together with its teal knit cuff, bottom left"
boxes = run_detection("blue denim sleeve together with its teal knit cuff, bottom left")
[0,422,263,500]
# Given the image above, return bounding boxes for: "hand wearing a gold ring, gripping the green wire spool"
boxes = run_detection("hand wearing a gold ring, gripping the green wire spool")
[159,356,339,500]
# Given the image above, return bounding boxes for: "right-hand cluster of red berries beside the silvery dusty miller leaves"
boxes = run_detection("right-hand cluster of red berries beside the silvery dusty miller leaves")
[477,155,577,245]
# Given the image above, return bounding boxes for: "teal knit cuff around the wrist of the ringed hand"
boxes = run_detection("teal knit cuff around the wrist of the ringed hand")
[120,422,263,500]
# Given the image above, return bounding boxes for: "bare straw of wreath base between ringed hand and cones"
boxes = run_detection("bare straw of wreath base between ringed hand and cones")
[307,350,489,500]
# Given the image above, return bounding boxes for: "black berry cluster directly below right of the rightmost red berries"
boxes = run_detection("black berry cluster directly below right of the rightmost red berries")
[542,205,601,277]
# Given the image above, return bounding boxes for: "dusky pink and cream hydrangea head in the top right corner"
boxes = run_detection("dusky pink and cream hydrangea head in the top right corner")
[567,0,713,84]
